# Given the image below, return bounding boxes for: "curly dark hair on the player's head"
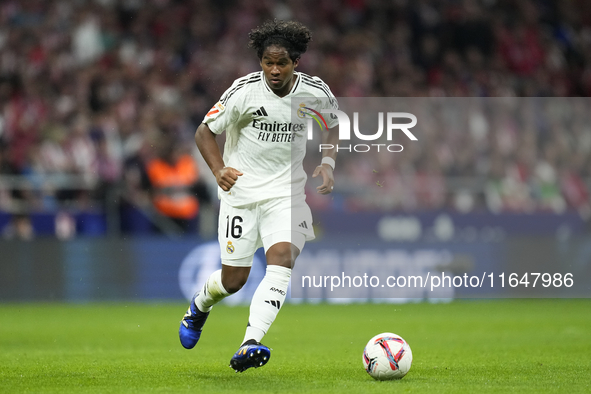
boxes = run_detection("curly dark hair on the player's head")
[248,19,312,62]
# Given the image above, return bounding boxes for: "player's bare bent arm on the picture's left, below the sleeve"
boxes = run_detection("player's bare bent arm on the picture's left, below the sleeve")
[195,123,242,192]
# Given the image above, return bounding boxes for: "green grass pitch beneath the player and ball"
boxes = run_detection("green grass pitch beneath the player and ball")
[0,300,591,394]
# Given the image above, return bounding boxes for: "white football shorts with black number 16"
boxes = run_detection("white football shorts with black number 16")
[218,196,315,267]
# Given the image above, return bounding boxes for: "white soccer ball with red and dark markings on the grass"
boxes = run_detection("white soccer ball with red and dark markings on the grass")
[363,332,412,380]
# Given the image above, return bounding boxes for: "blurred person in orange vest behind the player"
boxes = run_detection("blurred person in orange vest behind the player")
[146,135,199,232]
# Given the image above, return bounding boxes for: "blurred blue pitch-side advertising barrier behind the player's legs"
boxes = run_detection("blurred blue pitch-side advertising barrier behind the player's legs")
[0,234,591,304]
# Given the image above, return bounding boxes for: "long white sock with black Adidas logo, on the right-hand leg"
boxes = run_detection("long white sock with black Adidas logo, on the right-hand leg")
[242,265,291,343]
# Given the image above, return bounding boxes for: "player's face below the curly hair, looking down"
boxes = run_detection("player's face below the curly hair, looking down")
[261,45,298,97]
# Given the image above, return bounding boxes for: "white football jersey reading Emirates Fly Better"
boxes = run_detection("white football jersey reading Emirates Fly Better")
[203,71,338,206]
